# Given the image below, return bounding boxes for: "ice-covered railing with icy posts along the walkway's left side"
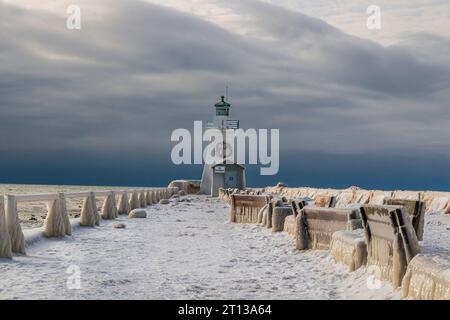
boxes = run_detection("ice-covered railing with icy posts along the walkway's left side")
[0,187,178,258]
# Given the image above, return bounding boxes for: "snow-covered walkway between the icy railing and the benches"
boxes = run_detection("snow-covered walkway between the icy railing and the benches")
[0,196,450,299]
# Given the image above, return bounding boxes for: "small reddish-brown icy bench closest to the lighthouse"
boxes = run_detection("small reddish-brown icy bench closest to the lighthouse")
[230,194,270,223]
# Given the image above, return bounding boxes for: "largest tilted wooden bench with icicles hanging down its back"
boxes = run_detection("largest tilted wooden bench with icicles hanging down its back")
[361,205,420,287]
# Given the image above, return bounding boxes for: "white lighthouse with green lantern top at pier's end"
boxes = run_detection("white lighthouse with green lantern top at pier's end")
[200,96,245,197]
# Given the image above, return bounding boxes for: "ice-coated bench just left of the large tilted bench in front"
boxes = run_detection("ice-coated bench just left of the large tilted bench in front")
[295,207,362,250]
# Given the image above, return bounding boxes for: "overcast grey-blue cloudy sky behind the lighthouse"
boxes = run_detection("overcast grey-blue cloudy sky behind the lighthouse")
[0,0,450,190]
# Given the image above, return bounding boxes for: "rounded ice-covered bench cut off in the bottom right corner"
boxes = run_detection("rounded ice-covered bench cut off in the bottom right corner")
[402,254,450,300]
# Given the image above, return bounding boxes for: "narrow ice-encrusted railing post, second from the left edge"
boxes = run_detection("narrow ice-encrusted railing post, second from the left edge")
[6,195,25,254]
